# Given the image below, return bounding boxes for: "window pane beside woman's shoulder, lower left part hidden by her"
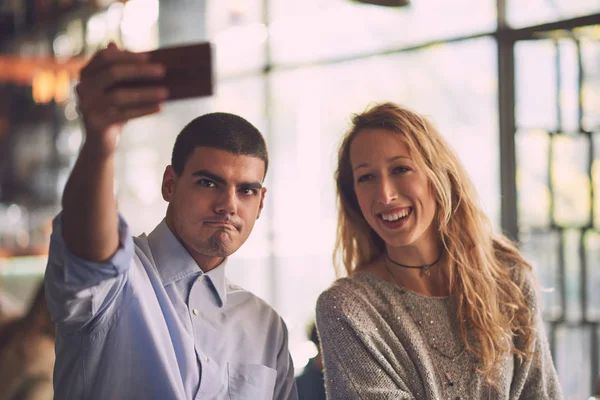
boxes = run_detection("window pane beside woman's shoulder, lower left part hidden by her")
[521,231,562,320]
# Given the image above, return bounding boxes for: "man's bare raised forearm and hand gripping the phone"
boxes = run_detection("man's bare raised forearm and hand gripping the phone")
[62,44,168,262]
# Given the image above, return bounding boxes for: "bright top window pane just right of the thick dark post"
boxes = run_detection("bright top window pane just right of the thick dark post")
[515,40,558,132]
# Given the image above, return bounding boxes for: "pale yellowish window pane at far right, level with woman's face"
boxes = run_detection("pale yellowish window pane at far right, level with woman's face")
[551,135,591,227]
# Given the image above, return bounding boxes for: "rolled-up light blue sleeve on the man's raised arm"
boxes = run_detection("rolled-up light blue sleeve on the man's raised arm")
[44,213,134,334]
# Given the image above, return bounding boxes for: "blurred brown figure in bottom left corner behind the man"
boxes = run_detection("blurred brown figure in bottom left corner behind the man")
[0,285,55,400]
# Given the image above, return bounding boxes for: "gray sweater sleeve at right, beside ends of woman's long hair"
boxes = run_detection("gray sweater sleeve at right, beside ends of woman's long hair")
[510,272,563,400]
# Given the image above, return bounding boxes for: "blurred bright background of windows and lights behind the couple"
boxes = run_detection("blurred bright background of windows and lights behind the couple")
[0,0,600,399]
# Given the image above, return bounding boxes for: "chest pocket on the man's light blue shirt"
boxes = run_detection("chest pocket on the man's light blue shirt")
[227,363,277,400]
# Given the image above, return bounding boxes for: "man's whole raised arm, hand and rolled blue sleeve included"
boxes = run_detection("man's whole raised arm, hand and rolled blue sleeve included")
[44,44,166,334]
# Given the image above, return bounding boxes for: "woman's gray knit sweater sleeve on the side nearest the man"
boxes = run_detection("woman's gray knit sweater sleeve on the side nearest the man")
[317,286,419,400]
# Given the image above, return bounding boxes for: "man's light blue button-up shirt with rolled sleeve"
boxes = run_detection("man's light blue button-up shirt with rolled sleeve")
[45,215,298,400]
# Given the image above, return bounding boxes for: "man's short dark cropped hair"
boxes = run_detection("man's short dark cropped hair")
[171,112,269,176]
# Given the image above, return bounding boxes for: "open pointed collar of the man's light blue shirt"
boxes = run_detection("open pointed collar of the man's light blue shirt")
[148,219,227,307]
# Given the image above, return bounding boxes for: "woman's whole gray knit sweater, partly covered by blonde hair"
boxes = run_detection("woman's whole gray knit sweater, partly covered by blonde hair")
[317,272,562,400]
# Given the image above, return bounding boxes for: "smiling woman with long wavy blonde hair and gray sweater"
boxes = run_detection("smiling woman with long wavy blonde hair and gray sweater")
[317,103,562,400]
